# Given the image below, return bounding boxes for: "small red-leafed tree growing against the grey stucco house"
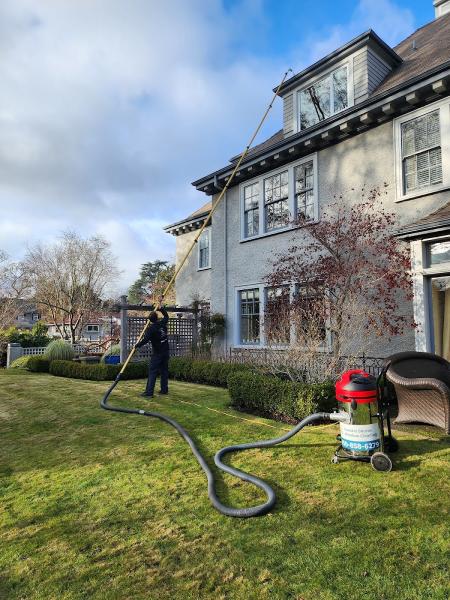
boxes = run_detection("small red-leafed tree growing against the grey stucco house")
[267,185,414,366]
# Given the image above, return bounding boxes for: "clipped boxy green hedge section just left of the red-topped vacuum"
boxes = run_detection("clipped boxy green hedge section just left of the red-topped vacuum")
[228,372,336,421]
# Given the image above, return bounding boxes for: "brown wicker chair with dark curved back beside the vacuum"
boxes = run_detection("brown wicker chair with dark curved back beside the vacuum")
[386,352,450,433]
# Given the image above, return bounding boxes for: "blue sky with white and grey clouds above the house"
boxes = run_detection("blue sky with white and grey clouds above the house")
[0,0,434,293]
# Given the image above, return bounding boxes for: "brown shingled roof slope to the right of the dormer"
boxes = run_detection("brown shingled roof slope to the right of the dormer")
[372,13,450,96]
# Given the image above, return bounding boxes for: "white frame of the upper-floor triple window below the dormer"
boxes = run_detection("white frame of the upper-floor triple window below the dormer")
[239,152,319,243]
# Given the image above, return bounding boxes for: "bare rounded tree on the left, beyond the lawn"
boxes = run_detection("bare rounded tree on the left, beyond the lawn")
[23,231,119,343]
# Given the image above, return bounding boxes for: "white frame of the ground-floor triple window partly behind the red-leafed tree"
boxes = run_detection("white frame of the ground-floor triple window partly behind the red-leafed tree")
[233,282,332,353]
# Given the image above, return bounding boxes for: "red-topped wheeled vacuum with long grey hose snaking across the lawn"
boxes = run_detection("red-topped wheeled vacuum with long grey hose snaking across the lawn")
[101,364,394,518]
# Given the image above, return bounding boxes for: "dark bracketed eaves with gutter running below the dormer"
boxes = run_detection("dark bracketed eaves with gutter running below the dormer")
[192,60,450,196]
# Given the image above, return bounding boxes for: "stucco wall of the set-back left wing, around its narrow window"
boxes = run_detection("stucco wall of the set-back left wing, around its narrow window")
[175,230,215,306]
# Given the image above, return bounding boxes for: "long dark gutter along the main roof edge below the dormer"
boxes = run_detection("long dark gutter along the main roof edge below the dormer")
[191,60,450,188]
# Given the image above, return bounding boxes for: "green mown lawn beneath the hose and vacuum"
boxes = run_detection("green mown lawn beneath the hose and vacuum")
[0,370,450,600]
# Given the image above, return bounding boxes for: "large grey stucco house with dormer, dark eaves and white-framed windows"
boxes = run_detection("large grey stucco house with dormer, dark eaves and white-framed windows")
[166,0,450,357]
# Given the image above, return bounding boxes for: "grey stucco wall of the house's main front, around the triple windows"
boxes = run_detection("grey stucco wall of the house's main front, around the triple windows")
[210,121,450,356]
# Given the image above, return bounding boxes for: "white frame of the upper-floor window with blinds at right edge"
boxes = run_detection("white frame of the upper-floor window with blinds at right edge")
[393,98,450,202]
